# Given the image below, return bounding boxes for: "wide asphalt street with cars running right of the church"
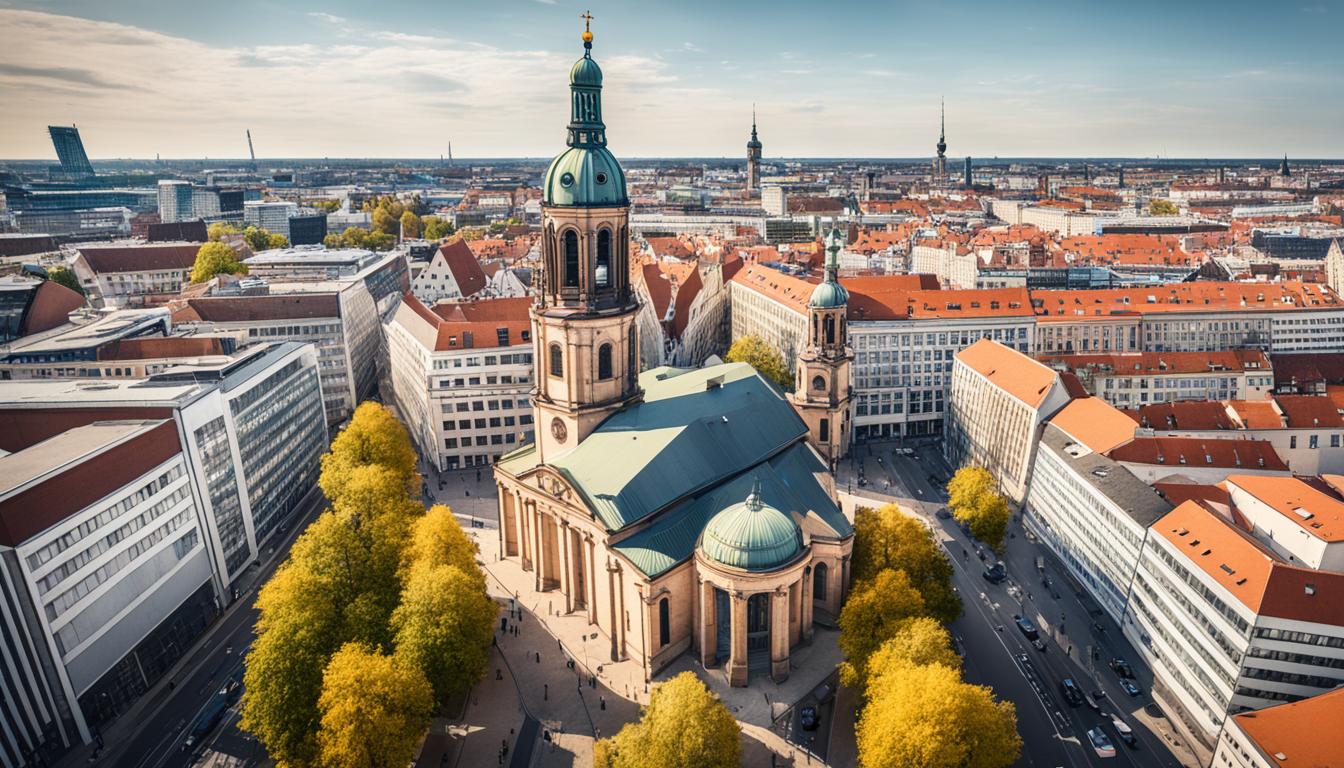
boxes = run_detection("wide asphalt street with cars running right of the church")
[837,444,1195,767]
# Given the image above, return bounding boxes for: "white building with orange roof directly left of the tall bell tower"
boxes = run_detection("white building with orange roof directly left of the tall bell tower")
[383,295,534,471]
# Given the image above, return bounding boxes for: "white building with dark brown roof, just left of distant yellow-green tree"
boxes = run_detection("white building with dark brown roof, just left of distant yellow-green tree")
[70,242,200,307]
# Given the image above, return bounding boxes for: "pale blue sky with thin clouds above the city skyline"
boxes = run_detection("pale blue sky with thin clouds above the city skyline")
[0,0,1344,159]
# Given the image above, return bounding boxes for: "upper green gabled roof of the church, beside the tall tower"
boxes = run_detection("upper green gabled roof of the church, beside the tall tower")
[532,363,806,531]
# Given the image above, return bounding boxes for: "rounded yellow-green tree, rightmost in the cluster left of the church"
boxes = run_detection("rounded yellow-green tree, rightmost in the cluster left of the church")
[392,564,499,699]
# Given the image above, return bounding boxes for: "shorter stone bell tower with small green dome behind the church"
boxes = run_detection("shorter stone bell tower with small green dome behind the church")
[789,229,853,469]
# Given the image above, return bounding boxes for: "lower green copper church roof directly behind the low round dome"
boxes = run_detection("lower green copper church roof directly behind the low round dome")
[612,443,853,578]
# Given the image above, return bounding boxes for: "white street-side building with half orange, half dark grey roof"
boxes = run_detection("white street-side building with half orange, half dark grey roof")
[1023,397,1172,623]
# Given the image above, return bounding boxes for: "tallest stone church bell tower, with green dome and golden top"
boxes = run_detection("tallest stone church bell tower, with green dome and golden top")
[531,13,642,461]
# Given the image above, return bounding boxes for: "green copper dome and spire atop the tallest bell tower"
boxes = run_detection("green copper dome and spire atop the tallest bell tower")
[542,32,629,206]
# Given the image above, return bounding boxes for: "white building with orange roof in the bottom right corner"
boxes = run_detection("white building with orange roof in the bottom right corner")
[1210,690,1344,768]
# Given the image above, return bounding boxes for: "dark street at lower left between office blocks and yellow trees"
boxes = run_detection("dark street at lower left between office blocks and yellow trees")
[98,492,325,768]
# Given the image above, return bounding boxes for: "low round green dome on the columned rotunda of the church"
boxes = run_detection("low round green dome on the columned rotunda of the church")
[700,482,802,570]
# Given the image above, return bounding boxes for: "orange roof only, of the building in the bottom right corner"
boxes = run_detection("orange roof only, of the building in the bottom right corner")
[1232,689,1344,768]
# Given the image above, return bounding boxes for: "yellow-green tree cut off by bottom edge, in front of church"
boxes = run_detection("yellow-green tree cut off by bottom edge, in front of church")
[593,673,742,768]
